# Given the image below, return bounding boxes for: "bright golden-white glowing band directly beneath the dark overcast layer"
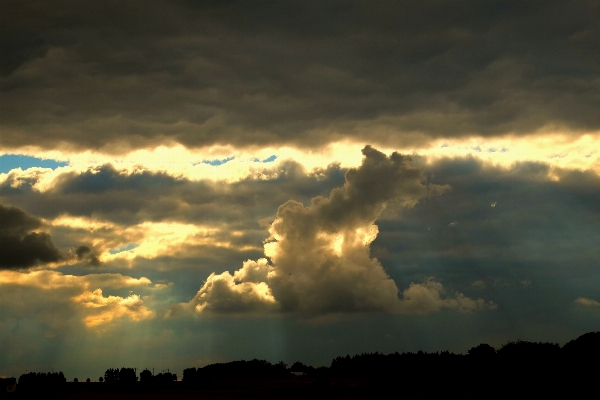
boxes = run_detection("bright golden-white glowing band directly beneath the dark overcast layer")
[0,131,600,191]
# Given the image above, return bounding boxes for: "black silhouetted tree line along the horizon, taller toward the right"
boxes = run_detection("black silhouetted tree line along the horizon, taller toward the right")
[12,332,600,398]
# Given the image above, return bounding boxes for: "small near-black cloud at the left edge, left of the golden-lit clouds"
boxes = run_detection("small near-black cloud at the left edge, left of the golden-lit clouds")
[0,204,62,269]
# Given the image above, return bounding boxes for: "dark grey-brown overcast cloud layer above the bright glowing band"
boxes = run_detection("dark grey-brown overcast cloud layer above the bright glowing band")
[0,1,600,151]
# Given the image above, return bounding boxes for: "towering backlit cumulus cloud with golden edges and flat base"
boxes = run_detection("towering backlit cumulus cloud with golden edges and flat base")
[173,146,488,313]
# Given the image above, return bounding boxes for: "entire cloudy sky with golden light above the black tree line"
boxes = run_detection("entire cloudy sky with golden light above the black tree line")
[0,0,600,380]
